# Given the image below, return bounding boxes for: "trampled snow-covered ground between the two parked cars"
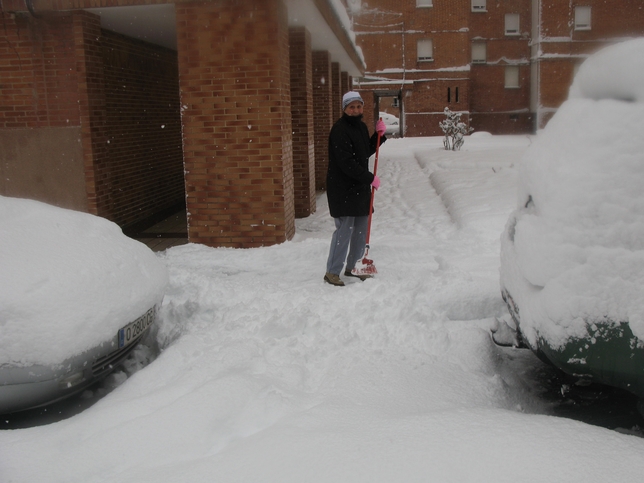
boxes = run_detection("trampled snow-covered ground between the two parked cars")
[0,133,644,483]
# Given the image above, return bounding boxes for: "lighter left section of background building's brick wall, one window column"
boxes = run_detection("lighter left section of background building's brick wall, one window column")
[356,0,470,136]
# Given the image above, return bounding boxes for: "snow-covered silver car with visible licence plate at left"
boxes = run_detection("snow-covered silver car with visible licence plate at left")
[0,196,168,414]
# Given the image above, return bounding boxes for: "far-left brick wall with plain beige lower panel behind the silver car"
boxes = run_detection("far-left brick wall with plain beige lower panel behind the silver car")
[0,13,96,213]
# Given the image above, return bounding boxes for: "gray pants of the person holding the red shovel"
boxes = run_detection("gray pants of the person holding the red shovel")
[326,216,369,275]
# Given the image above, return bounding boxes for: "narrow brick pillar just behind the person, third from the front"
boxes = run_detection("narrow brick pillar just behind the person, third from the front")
[313,51,334,190]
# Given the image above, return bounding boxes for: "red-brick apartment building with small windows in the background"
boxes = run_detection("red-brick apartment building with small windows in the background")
[348,0,644,136]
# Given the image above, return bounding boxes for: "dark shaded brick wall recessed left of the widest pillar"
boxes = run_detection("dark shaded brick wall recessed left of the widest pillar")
[101,31,184,231]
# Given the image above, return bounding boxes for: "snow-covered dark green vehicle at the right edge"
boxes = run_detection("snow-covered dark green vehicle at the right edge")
[500,39,644,408]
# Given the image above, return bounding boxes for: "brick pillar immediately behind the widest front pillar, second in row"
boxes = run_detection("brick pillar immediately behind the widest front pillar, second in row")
[289,27,316,218]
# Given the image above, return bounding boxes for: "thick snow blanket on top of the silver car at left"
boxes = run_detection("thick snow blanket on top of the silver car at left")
[0,196,168,364]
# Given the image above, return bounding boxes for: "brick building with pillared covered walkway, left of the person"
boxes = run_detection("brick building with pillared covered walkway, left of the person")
[0,0,365,248]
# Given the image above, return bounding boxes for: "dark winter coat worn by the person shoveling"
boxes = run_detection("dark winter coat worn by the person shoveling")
[326,114,386,218]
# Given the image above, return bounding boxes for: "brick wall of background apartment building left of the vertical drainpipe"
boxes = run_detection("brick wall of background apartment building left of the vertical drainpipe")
[356,0,532,136]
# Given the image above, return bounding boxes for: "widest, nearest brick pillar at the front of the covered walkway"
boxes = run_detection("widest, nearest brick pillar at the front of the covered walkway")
[176,0,295,248]
